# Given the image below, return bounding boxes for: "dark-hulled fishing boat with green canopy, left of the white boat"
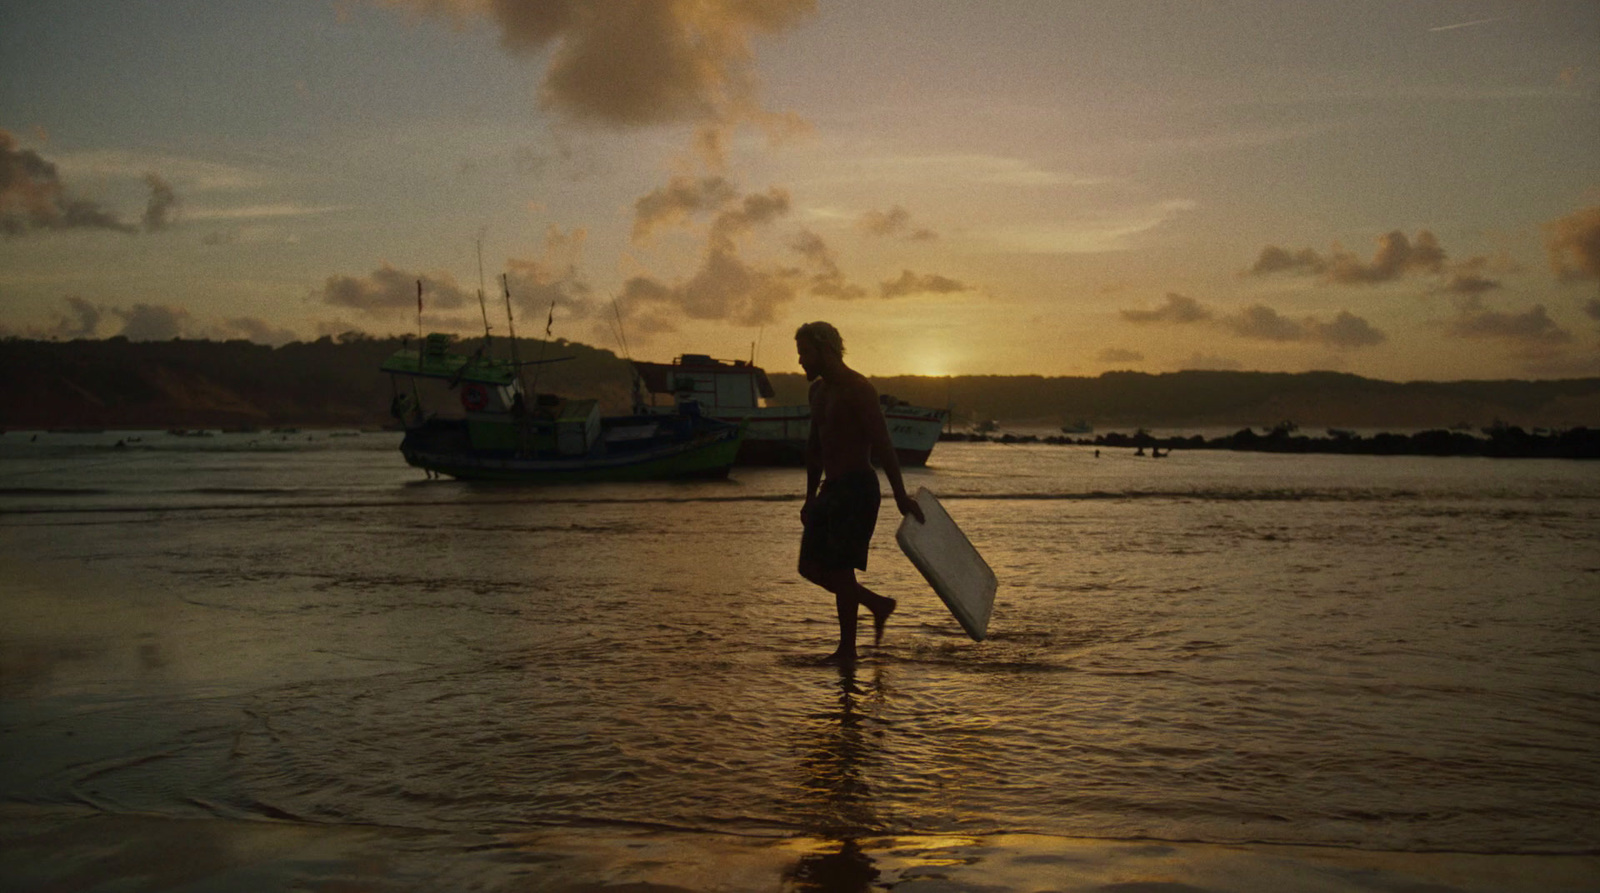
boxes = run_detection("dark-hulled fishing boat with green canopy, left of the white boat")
[381,334,744,483]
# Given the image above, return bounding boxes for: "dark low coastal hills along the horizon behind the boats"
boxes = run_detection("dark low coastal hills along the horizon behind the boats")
[0,333,1600,430]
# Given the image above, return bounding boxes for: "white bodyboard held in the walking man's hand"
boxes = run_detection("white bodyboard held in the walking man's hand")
[894,487,1000,642]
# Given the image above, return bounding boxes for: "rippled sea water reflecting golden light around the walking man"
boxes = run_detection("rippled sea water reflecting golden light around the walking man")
[0,432,1600,875]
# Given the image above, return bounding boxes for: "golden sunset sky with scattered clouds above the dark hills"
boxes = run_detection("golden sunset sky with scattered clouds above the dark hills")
[0,0,1600,379]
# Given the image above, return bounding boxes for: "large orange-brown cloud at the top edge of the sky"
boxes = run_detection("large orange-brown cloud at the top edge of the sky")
[374,0,816,139]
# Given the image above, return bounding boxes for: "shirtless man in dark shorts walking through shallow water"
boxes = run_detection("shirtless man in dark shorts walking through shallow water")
[795,322,923,664]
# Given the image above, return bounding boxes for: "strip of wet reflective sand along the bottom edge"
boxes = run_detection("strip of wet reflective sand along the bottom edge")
[0,805,1600,893]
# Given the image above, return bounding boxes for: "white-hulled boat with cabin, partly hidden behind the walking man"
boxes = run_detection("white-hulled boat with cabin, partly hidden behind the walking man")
[634,354,949,466]
